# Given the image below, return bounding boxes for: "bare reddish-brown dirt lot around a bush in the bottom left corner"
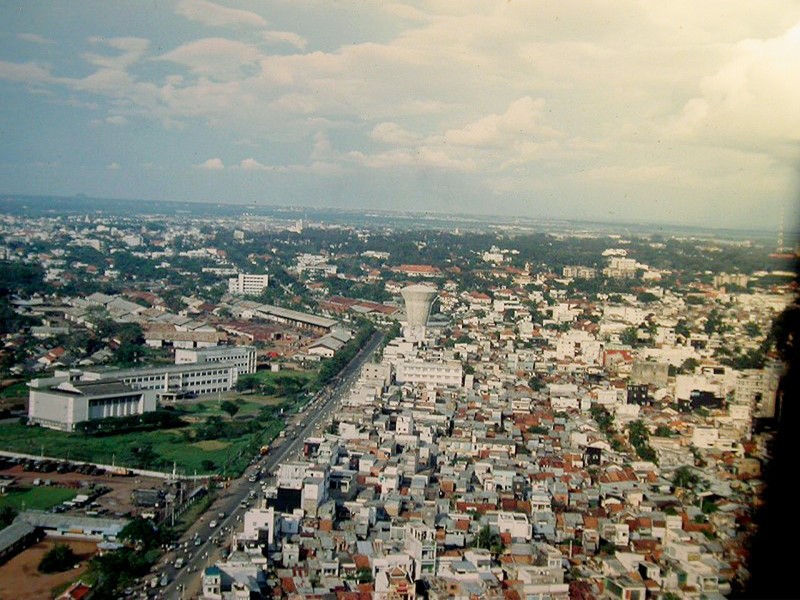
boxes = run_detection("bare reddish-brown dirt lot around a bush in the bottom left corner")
[0,538,97,600]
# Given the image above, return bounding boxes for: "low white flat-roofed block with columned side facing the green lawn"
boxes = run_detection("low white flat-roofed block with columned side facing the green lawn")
[28,376,156,431]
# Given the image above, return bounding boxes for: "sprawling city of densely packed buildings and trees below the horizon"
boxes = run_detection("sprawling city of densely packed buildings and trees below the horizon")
[0,203,794,600]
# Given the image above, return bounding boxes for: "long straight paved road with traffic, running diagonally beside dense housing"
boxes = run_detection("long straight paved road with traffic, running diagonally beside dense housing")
[156,332,384,599]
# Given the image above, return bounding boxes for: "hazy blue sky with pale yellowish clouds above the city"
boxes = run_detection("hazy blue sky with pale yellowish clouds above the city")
[0,0,800,230]
